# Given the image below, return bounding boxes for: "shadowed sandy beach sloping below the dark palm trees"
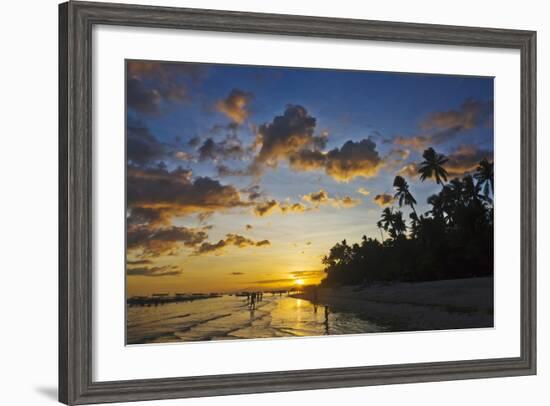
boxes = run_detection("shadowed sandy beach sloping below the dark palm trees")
[294,277,493,331]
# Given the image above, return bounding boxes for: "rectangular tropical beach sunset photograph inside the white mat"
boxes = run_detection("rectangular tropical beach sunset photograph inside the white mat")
[126,60,500,345]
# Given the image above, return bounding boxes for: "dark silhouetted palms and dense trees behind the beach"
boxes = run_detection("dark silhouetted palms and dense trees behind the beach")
[322,148,494,286]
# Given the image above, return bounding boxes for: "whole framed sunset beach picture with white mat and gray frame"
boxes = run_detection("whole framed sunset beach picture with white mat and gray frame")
[59,2,536,404]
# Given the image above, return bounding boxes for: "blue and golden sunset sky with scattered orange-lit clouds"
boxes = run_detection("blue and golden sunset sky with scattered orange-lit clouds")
[126,61,493,296]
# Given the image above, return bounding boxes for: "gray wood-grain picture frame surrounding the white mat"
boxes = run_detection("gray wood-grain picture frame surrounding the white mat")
[59,2,536,404]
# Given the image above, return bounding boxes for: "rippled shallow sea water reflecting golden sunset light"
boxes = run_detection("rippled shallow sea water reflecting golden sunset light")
[126,294,384,344]
